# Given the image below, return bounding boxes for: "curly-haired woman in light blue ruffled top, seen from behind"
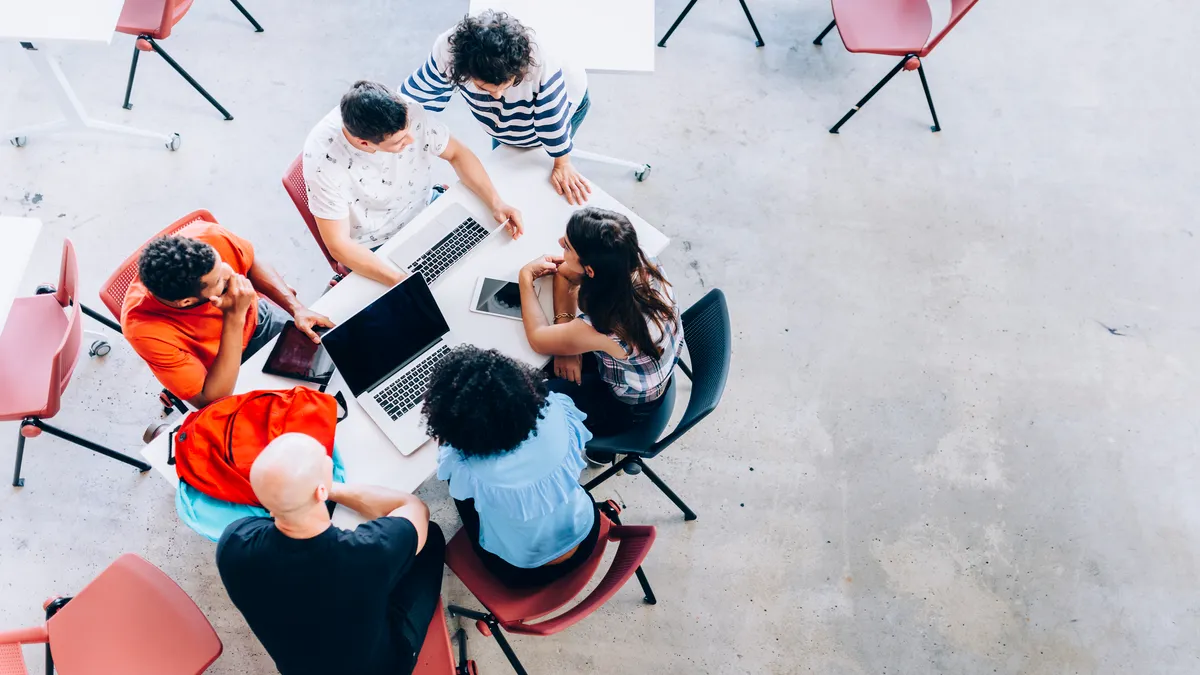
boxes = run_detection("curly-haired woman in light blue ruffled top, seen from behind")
[424,346,600,587]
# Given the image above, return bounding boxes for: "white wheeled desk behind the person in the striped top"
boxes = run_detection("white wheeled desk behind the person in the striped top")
[468,0,654,181]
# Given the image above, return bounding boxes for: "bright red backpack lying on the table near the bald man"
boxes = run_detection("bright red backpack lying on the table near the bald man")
[173,387,338,506]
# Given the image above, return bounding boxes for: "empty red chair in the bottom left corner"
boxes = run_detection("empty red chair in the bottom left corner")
[0,554,222,675]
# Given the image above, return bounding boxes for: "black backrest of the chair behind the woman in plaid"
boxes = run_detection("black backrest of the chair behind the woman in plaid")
[649,288,733,456]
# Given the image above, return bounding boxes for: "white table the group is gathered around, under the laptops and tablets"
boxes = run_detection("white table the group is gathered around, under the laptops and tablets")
[142,147,670,525]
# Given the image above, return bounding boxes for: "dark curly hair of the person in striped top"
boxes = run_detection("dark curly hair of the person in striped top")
[448,10,538,84]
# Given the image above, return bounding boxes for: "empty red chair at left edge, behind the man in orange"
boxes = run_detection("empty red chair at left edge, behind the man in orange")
[0,239,150,488]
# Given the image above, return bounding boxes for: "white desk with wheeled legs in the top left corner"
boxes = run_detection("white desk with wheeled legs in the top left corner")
[0,0,180,150]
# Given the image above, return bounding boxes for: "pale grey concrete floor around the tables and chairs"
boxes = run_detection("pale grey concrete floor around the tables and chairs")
[0,0,1200,675]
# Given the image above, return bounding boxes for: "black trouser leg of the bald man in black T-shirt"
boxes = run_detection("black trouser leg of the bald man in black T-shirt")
[388,521,446,674]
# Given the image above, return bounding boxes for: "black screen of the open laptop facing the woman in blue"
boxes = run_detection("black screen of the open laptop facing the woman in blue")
[320,274,450,398]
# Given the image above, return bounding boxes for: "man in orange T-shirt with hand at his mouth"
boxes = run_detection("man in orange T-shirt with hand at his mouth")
[121,221,334,408]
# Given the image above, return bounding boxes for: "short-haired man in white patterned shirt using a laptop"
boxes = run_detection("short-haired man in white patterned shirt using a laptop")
[302,80,522,286]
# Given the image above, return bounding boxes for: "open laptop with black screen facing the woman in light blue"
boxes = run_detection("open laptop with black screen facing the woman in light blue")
[320,274,460,455]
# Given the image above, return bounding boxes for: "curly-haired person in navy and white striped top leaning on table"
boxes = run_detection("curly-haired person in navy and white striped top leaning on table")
[401,10,592,204]
